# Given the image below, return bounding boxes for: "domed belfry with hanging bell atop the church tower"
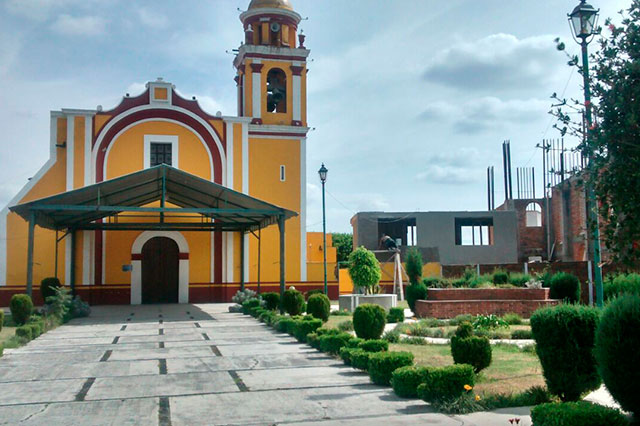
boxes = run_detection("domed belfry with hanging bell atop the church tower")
[234,0,309,127]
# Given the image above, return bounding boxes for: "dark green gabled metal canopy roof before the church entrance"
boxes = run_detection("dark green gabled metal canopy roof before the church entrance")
[9,164,297,232]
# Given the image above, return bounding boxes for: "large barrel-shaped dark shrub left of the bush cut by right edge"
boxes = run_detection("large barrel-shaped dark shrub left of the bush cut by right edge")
[531,304,600,401]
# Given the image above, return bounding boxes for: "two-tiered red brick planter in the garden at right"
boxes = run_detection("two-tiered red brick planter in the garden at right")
[415,288,558,318]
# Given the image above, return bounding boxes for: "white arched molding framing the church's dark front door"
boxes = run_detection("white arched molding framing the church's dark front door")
[131,231,189,305]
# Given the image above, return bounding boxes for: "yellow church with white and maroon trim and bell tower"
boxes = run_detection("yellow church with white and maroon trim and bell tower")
[0,0,338,305]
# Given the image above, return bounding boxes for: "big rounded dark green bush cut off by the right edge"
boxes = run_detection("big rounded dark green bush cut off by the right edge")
[595,294,640,418]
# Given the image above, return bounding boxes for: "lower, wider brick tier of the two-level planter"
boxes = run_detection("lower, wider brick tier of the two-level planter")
[415,300,558,319]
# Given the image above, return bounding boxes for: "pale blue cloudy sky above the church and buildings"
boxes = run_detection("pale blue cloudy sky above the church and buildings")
[0,0,631,232]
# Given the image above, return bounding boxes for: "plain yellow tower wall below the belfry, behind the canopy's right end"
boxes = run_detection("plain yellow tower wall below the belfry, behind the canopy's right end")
[249,138,300,281]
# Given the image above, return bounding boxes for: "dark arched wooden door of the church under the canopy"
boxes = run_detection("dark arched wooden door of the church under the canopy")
[142,237,180,303]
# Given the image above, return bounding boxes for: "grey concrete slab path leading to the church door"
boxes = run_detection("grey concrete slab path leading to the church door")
[0,304,530,426]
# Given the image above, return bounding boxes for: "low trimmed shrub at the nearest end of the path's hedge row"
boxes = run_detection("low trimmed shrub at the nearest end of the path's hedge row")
[418,364,476,402]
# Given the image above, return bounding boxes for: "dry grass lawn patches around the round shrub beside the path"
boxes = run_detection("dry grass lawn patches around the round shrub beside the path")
[389,344,544,394]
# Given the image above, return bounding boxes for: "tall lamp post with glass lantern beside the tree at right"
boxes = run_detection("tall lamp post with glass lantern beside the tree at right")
[568,0,603,307]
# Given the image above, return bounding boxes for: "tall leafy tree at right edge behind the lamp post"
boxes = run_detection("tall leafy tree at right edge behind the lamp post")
[551,0,640,265]
